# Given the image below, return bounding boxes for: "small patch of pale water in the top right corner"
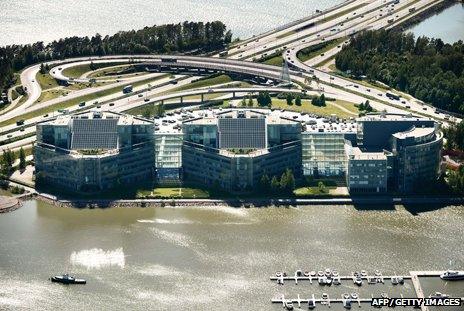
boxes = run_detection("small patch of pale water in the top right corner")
[409,3,464,43]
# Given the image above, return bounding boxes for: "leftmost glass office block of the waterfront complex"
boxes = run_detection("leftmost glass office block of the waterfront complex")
[34,112,154,192]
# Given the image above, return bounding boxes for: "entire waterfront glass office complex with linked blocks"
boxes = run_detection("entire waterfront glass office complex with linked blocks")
[36,109,443,194]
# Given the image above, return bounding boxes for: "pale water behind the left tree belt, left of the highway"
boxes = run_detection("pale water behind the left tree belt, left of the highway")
[0,0,342,45]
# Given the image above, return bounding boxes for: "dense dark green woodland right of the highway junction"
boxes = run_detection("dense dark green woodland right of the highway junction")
[335,30,464,113]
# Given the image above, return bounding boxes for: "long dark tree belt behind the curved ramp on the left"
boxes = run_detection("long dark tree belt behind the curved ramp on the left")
[0,21,232,96]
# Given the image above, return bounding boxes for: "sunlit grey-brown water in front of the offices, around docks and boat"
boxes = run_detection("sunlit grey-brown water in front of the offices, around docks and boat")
[0,201,464,311]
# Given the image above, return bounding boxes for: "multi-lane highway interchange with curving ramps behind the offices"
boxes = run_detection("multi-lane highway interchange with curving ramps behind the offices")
[0,0,459,155]
